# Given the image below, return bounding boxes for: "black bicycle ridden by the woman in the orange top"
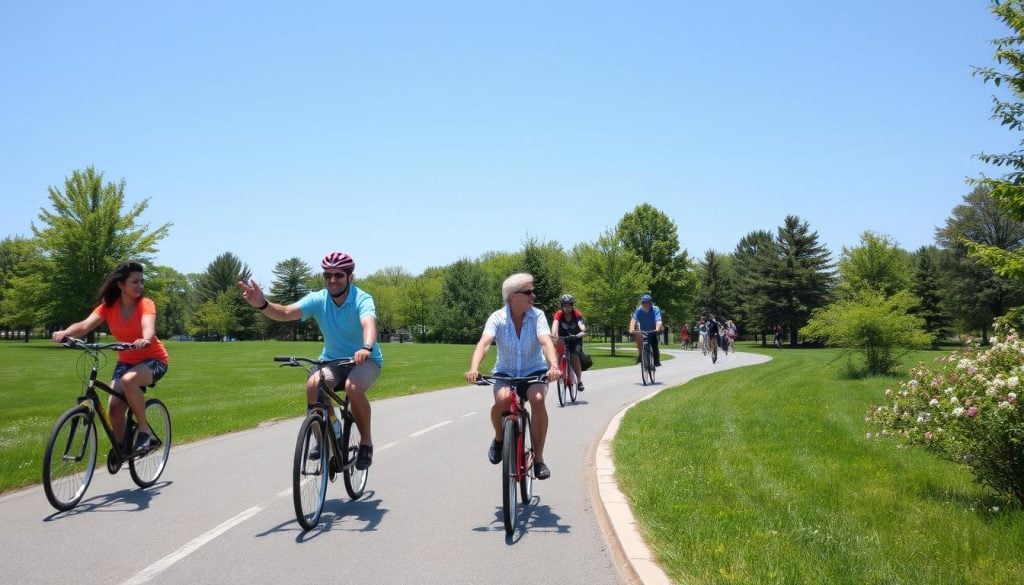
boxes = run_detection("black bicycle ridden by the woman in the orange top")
[43,337,171,511]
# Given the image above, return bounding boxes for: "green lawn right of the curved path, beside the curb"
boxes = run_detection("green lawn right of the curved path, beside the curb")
[613,344,1024,584]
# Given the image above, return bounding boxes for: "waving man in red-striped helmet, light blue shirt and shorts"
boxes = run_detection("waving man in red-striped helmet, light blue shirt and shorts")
[239,252,384,469]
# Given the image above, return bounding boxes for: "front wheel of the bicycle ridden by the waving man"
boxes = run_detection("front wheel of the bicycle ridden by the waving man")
[292,412,331,530]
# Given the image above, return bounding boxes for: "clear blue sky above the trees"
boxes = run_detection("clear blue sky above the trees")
[0,0,1018,283]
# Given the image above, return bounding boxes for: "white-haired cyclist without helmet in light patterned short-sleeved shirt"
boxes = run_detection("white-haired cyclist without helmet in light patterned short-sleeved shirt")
[465,273,561,479]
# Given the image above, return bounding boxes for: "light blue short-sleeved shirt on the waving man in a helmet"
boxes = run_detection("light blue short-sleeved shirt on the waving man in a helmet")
[296,285,384,366]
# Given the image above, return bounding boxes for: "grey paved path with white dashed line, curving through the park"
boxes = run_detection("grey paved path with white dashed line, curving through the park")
[0,349,765,585]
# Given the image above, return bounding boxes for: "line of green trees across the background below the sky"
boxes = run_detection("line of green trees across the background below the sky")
[0,167,1024,356]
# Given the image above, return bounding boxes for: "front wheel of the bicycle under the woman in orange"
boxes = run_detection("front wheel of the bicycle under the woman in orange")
[43,406,96,511]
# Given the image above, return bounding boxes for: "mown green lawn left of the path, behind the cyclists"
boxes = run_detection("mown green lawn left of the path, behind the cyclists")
[0,340,635,492]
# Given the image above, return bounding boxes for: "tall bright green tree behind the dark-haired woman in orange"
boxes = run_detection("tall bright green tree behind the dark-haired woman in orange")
[32,167,171,325]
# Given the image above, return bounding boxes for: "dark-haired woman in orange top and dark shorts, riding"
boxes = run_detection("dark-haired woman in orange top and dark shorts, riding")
[51,262,168,452]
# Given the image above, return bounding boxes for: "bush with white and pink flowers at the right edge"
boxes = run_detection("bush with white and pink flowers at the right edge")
[867,325,1024,504]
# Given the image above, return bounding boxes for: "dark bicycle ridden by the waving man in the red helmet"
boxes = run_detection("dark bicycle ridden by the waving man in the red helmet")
[273,356,370,530]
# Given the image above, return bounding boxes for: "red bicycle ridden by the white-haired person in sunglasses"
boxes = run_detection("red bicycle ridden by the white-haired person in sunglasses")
[476,375,548,536]
